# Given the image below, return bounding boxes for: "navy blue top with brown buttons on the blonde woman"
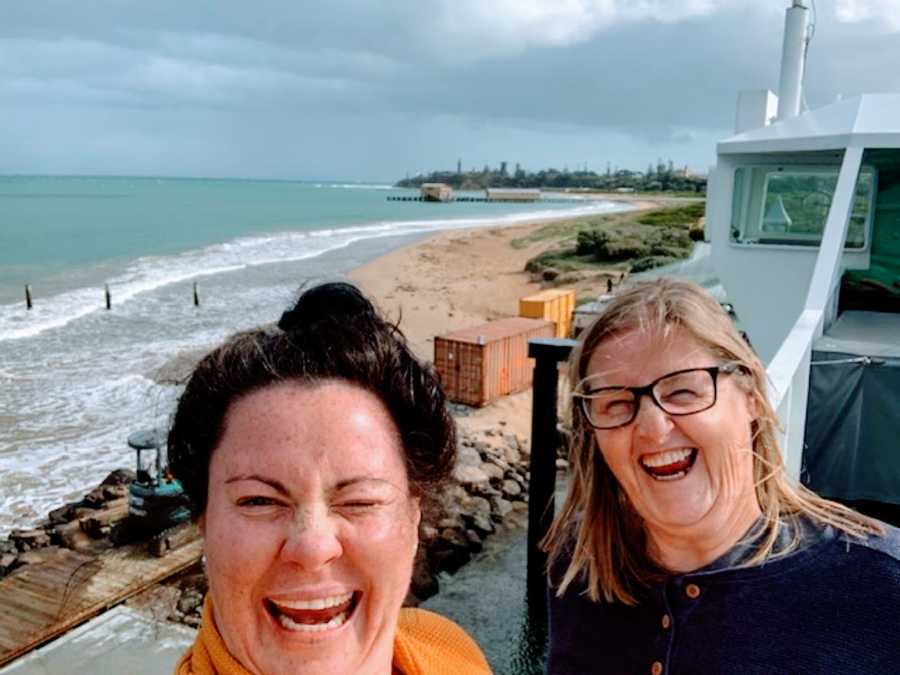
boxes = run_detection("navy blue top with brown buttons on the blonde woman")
[547,524,900,675]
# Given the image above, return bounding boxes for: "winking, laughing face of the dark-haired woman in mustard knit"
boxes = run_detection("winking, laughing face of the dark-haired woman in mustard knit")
[201,380,420,675]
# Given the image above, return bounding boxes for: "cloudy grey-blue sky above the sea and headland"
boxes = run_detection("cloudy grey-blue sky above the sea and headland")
[0,0,900,182]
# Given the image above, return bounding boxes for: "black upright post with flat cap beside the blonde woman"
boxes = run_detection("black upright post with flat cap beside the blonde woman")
[527,338,578,597]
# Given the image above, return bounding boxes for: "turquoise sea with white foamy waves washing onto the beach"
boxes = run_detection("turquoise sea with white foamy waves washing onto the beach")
[0,177,616,535]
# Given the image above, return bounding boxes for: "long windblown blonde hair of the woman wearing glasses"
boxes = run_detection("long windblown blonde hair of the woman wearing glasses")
[542,278,884,605]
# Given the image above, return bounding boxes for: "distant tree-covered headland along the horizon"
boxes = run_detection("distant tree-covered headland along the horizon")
[397,160,706,197]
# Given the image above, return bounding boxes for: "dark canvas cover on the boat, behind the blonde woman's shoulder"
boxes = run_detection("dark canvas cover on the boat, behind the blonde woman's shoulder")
[801,351,900,504]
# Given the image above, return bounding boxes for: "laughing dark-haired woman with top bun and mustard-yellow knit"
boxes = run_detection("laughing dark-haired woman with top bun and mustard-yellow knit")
[169,283,490,675]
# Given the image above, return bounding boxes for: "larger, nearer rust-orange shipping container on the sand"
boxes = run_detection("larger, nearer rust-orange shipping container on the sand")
[434,318,554,406]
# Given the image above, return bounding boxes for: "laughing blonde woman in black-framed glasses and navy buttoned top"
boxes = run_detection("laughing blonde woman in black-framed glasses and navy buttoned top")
[545,279,900,675]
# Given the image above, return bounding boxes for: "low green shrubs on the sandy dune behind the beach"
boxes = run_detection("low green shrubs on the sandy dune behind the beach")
[524,203,703,279]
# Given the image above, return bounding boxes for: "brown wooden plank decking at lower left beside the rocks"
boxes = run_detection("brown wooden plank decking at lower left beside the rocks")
[0,534,202,666]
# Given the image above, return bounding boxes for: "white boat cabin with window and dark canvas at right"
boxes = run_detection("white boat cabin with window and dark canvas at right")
[707,92,900,515]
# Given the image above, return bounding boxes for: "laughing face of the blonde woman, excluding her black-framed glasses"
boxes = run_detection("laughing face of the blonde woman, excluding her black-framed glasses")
[587,328,759,541]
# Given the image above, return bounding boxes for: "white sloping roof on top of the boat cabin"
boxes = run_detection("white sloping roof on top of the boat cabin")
[717,94,900,155]
